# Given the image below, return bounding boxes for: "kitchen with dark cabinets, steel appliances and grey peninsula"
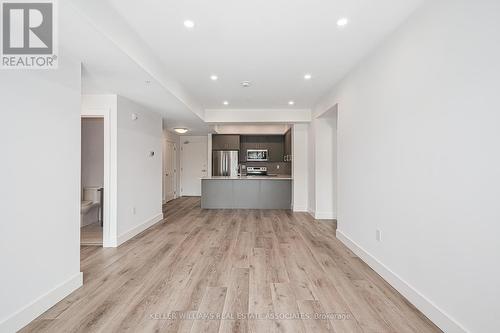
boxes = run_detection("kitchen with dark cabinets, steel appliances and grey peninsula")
[201,131,293,209]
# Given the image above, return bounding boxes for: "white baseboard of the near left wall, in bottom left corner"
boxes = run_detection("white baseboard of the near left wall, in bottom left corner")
[0,272,83,333]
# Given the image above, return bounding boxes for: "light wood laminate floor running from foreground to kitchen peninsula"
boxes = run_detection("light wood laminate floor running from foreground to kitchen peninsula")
[23,198,440,333]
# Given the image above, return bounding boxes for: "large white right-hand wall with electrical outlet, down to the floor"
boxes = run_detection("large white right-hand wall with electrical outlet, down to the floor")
[316,0,500,332]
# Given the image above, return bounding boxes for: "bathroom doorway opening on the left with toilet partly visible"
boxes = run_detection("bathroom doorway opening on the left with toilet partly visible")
[80,117,106,246]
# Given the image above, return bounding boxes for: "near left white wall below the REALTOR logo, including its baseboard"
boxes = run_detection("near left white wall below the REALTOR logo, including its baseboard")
[0,57,82,332]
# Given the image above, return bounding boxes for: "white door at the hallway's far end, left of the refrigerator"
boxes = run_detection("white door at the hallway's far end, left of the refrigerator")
[181,137,208,196]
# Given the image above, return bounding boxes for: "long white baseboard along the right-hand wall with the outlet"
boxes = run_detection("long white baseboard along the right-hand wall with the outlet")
[337,230,468,333]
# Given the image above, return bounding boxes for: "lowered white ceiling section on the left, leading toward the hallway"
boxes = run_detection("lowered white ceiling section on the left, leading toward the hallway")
[59,3,209,134]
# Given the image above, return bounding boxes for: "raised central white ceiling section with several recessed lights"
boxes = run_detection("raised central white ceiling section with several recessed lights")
[108,0,422,109]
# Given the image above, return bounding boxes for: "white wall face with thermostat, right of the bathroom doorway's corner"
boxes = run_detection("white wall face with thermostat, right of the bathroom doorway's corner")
[117,96,163,244]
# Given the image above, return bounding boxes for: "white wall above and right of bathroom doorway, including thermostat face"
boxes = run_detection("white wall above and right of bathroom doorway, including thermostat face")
[82,95,163,247]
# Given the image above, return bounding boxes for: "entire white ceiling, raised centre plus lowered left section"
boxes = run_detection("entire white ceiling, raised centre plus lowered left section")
[68,0,424,132]
